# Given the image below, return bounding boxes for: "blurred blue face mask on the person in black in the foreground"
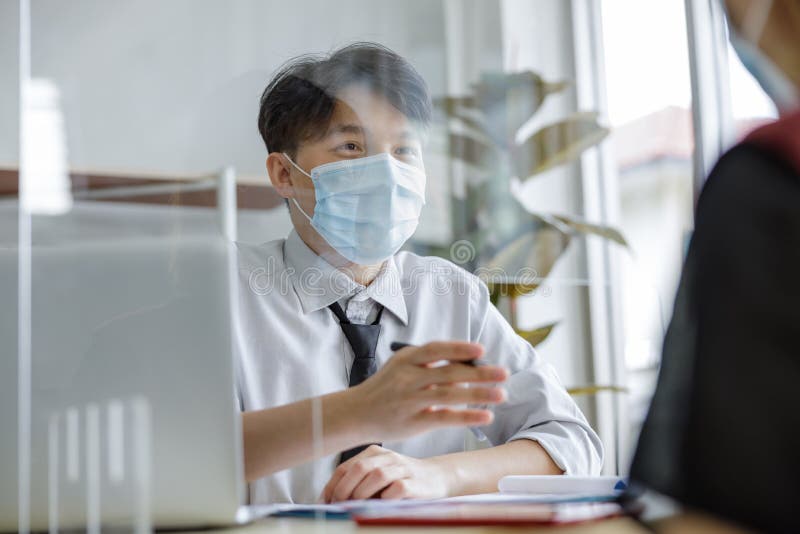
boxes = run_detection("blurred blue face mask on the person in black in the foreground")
[728,2,800,112]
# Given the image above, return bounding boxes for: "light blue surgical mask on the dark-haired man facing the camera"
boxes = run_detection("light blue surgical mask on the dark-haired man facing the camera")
[284,153,425,265]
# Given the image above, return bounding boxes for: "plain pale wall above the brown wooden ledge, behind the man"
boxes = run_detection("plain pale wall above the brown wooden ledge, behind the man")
[0,0,444,179]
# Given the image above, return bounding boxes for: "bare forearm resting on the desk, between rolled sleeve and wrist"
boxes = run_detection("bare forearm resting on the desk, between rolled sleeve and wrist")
[430,439,563,496]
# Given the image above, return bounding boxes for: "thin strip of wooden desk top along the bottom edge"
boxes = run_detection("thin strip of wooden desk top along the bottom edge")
[199,517,648,534]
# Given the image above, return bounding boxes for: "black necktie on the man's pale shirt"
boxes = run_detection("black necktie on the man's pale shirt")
[328,302,383,463]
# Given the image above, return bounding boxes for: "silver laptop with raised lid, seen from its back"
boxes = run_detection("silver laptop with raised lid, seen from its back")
[0,237,246,531]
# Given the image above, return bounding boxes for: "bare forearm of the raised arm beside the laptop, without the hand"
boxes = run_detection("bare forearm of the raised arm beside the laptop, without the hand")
[242,391,361,482]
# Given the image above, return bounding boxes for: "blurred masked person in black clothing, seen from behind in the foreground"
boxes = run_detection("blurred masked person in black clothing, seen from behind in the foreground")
[631,0,800,532]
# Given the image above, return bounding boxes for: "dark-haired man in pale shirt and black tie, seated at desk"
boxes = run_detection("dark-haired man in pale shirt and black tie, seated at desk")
[236,43,602,503]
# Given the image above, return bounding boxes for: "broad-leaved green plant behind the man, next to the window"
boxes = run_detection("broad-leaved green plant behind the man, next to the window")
[426,71,627,394]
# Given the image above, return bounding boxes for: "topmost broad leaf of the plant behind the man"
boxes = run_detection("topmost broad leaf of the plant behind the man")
[474,71,569,147]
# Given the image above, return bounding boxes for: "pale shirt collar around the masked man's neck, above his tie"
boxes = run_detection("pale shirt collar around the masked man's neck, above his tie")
[283,230,408,326]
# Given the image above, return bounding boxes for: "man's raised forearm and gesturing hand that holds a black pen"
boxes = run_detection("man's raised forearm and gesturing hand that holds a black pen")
[242,341,508,481]
